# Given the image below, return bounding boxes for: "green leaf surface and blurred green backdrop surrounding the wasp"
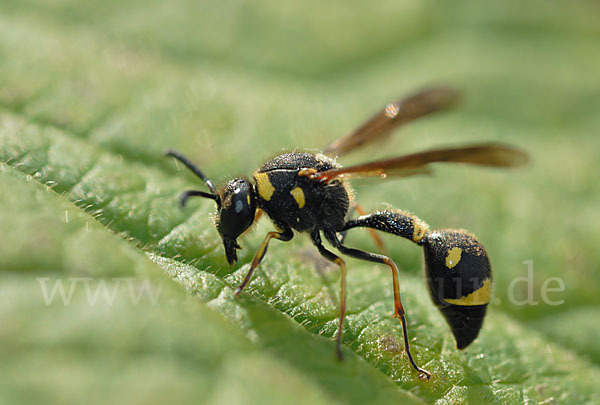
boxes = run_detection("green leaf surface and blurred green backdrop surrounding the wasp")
[0,0,600,404]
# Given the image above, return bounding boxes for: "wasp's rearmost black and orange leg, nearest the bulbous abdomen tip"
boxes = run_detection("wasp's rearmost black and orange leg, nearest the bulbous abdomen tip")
[325,231,431,380]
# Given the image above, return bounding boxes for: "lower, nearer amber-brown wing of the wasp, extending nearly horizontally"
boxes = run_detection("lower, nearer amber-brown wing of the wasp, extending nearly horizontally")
[313,144,529,182]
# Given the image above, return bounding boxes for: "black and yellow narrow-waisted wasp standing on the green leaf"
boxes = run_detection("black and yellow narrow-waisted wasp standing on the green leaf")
[167,87,528,380]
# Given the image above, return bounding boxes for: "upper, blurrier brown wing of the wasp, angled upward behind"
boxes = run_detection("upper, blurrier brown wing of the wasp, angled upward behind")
[323,87,459,156]
